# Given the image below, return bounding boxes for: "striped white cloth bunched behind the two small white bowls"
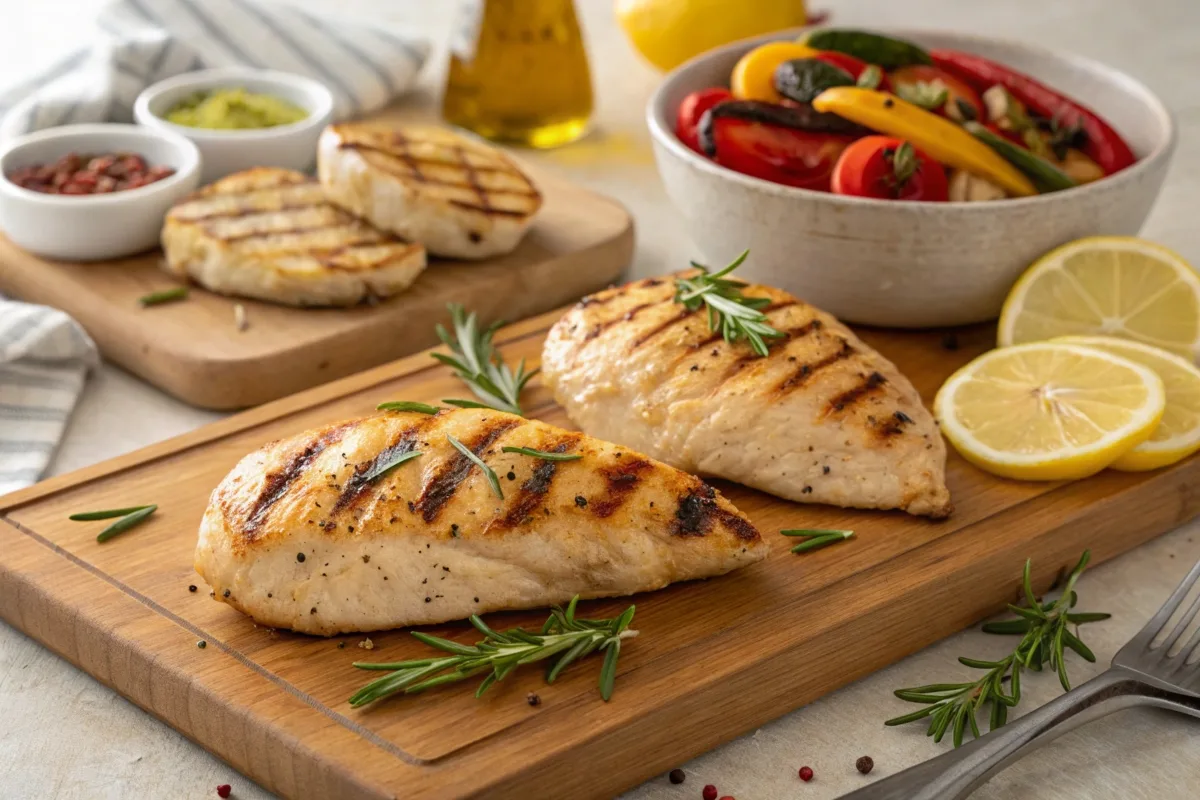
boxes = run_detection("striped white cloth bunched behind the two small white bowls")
[0,0,430,142]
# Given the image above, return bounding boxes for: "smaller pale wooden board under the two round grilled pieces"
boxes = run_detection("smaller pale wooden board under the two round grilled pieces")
[0,166,634,409]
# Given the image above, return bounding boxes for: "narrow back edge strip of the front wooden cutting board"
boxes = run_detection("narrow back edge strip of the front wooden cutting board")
[0,309,564,513]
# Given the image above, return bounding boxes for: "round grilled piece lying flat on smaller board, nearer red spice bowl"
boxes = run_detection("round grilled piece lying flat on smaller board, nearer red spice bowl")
[162,167,425,306]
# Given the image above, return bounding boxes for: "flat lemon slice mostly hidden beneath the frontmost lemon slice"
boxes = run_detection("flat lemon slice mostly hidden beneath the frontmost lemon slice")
[1055,336,1200,473]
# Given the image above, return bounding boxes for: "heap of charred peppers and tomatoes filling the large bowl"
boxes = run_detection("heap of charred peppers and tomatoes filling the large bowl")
[677,29,1135,201]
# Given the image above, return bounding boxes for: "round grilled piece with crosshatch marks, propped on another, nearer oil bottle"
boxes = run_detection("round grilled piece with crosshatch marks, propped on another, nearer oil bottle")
[317,122,541,258]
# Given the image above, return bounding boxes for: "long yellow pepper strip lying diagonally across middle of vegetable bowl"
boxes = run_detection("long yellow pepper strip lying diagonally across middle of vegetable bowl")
[812,86,1038,197]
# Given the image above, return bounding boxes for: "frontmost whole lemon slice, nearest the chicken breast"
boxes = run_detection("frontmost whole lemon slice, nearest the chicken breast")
[934,342,1166,481]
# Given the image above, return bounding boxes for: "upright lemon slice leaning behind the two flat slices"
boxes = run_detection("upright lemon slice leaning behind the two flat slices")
[1000,236,1200,361]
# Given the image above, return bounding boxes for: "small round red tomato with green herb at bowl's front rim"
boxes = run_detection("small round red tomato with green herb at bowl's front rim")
[832,136,948,203]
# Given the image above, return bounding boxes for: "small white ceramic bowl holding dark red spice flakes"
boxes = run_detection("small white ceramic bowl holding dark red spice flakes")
[0,124,200,261]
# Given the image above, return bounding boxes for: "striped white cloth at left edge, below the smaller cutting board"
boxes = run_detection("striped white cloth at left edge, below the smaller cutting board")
[0,296,100,494]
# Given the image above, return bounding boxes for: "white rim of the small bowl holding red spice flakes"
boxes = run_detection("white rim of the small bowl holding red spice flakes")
[0,122,200,209]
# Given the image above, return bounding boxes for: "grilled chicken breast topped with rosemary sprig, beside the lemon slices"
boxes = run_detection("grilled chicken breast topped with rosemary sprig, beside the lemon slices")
[542,278,952,517]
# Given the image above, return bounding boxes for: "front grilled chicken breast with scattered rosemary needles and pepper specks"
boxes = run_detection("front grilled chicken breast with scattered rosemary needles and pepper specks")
[196,409,767,634]
